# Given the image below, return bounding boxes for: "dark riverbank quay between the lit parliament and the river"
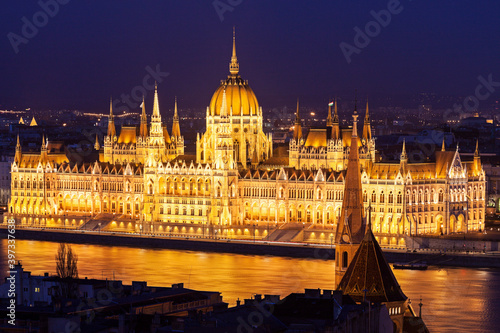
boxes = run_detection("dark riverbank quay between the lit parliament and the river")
[0,226,500,268]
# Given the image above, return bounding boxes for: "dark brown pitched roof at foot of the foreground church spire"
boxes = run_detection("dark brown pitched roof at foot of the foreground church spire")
[338,228,407,302]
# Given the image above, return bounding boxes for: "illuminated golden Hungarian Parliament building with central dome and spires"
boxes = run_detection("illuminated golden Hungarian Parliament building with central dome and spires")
[4,36,486,245]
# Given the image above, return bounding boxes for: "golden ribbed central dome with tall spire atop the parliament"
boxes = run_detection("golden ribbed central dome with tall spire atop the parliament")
[210,31,259,116]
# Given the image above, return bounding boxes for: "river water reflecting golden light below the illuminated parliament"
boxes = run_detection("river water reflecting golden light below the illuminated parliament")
[0,239,500,332]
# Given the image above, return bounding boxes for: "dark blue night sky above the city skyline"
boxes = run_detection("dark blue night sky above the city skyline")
[0,0,500,111]
